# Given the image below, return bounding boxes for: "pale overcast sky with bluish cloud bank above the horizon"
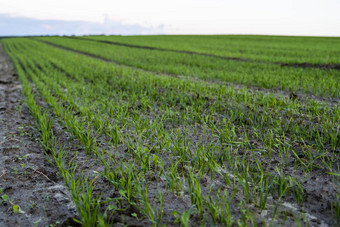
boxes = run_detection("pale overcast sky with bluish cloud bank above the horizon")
[0,0,340,36]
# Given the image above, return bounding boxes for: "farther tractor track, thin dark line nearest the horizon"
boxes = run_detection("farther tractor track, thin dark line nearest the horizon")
[72,37,340,70]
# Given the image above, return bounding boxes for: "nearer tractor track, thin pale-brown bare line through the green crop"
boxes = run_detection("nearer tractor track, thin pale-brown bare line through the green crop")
[34,39,340,106]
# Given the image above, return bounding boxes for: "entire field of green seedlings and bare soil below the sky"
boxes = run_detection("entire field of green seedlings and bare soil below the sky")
[0,36,340,226]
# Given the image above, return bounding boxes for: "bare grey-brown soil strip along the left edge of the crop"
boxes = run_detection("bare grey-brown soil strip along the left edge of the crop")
[0,44,77,226]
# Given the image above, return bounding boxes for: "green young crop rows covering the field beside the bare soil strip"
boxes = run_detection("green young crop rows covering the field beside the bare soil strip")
[1,37,340,226]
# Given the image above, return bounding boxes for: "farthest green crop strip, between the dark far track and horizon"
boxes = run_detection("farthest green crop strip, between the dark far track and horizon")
[81,35,340,64]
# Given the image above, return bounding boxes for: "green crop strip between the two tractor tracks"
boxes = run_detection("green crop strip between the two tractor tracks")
[33,37,340,97]
